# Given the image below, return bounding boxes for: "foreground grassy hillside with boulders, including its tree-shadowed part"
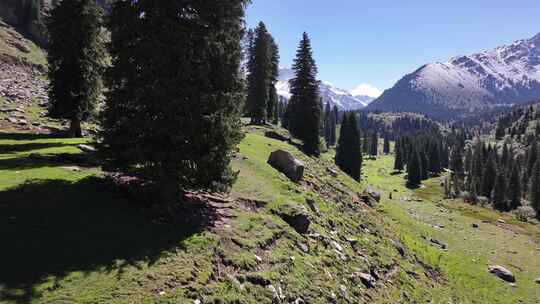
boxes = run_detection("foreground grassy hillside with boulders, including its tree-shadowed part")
[0,129,438,303]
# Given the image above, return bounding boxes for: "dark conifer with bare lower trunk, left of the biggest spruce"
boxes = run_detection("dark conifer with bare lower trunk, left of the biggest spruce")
[47,0,106,137]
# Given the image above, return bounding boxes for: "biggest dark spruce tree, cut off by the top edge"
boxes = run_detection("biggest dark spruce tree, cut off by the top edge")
[100,0,247,203]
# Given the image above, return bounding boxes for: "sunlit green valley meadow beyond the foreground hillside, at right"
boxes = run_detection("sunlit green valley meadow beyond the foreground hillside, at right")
[365,151,540,303]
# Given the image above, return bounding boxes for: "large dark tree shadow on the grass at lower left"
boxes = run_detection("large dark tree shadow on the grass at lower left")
[0,177,212,303]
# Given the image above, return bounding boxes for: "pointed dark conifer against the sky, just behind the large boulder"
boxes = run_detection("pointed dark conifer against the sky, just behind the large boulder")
[289,33,321,156]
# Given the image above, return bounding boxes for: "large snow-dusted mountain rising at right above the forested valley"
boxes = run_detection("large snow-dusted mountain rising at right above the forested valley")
[367,34,540,118]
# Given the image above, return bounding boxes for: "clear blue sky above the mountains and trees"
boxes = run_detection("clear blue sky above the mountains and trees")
[246,0,540,95]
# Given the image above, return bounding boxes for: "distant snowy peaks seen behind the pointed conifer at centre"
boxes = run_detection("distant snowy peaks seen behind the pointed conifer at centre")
[276,68,374,111]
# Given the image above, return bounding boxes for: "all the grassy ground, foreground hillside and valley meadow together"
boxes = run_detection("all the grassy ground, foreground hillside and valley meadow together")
[0,127,540,303]
